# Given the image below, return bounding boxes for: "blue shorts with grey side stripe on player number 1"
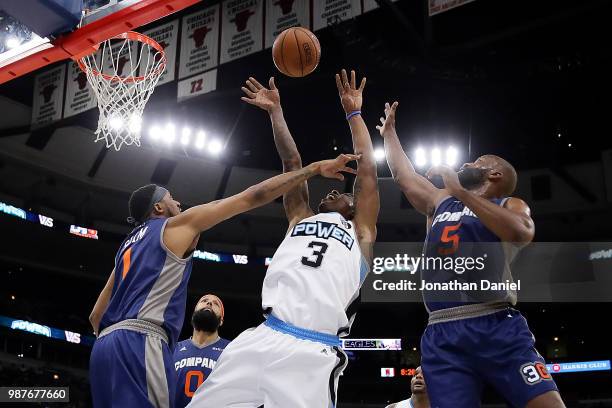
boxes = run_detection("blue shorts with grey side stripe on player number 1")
[89,330,176,408]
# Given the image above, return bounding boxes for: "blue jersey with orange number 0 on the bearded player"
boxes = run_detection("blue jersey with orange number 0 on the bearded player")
[174,338,229,408]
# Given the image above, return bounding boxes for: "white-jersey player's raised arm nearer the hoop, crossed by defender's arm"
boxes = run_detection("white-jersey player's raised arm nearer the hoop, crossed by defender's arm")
[241,77,313,229]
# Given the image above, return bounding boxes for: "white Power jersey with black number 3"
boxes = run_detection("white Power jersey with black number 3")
[261,212,368,336]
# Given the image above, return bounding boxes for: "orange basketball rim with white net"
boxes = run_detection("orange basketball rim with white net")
[75,31,166,150]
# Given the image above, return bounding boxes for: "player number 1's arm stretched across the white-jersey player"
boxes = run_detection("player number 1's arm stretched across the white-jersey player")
[164,154,359,254]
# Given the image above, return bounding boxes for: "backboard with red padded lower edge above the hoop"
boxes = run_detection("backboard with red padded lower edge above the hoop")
[0,0,200,84]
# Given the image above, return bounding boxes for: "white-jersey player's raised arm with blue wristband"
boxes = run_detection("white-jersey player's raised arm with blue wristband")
[336,69,380,252]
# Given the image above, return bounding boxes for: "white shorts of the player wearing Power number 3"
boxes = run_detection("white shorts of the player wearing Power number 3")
[188,324,347,408]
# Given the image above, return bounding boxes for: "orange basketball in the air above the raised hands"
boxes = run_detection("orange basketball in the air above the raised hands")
[272,27,321,78]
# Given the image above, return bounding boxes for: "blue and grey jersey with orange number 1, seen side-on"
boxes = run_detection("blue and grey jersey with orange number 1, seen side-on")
[100,218,193,350]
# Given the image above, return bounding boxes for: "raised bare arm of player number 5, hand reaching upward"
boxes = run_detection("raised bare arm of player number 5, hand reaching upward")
[376,102,448,216]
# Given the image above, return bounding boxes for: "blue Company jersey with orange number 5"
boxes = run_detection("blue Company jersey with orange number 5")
[420,196,518,311]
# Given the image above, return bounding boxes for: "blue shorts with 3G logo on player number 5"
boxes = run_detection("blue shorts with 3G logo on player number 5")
[421,308,557,408]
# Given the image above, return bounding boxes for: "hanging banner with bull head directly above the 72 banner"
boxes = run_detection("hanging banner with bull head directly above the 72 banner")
[179,5,220,79]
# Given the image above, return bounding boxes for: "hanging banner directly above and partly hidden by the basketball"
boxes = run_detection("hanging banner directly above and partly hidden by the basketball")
[266,0,310,48]
